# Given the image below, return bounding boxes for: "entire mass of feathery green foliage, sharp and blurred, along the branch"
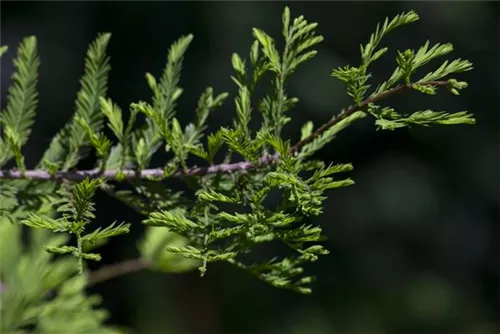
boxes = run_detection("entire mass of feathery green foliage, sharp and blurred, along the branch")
[0,8,474,333]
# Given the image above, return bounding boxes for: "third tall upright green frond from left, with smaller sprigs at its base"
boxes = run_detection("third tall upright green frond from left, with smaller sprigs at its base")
[128,35,228,176]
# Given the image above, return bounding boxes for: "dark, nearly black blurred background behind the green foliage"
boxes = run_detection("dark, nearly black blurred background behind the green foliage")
[0,0,500,334]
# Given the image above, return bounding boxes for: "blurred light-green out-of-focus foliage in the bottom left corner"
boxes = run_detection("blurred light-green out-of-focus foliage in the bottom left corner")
[0,219,123,334]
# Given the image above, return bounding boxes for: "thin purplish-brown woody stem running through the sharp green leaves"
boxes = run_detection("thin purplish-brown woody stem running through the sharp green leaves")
[0,81,448,181]
